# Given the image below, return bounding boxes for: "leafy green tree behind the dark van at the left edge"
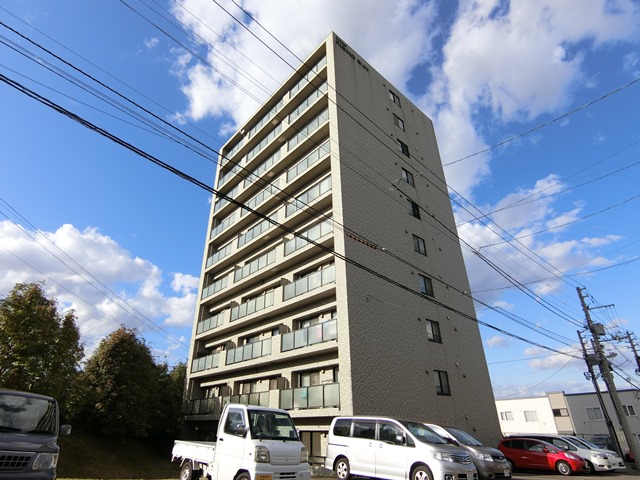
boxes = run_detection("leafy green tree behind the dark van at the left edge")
[0,282,84,415]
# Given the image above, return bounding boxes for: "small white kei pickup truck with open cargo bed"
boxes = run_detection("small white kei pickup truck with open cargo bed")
[171,403,311,480]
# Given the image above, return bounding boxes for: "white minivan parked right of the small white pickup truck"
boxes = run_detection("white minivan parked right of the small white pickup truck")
[325,417,478,480]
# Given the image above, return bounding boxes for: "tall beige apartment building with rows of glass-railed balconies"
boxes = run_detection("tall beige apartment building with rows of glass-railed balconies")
[186,34,500,456]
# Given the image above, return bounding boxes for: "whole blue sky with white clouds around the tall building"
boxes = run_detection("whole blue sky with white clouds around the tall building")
[0,0,640,398]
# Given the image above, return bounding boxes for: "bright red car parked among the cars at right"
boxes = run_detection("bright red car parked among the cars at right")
[498,437,590,475]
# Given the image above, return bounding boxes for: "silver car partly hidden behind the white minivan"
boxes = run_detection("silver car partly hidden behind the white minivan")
[427,423,511,480]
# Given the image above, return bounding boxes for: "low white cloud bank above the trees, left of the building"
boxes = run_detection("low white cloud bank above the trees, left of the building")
[0,221,198,358]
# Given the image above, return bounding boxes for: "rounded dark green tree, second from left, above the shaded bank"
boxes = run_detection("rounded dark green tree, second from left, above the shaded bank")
[85,327,165,437]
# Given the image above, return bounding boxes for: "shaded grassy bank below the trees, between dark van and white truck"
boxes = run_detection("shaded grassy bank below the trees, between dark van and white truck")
[58,432,180,480]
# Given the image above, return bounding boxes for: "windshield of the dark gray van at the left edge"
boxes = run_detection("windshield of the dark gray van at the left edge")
[0,393,57,435]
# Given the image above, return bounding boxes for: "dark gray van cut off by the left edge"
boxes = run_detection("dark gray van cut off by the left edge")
[0,390,71,480]
